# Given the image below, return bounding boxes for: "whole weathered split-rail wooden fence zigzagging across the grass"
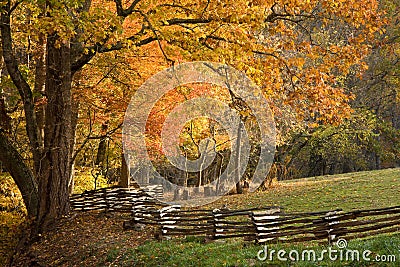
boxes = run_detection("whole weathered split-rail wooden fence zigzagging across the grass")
[71,188,400,243]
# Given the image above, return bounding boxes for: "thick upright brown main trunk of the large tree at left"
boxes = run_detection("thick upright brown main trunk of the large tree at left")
[37,35,73,231]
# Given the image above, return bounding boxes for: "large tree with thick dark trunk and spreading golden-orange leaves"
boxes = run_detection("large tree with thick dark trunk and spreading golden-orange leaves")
[0,0,380,230]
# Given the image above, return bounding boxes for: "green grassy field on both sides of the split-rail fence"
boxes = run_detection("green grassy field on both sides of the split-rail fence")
[103,169,400,266]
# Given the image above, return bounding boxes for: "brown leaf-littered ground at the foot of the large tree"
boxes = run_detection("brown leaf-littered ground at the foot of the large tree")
[13,212,153,266]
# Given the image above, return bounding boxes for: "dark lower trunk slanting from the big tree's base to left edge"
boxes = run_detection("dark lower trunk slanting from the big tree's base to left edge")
[0,130,38,218]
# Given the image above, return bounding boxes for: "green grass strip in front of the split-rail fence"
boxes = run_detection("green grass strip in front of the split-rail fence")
[107,235,400,266]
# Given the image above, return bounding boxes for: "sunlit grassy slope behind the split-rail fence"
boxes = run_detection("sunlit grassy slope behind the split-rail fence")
[210,168,400,212]
